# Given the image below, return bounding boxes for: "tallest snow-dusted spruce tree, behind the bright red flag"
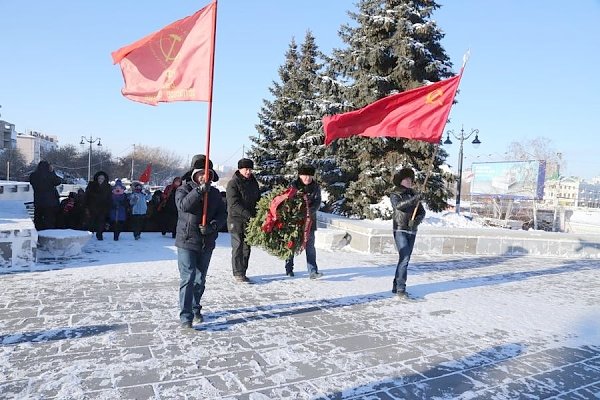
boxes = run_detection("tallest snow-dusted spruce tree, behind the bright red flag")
[326,0,453,218]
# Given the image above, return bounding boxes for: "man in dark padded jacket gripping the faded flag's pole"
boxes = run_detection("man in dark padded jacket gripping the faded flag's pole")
[175,154,227,328]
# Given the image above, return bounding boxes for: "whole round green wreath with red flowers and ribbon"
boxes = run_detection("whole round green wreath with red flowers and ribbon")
[246,186,313,260]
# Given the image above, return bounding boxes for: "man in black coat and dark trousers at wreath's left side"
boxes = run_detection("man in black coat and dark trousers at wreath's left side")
[226,158,260,282]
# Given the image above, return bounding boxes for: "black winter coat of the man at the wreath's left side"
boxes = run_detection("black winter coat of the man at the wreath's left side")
[226,171,260,233]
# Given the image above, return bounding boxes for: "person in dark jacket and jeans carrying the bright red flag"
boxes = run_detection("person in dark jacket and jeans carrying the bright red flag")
[390,168,425,297]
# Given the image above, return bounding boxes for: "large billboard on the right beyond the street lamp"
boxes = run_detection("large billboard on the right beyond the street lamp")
[471,160,546,200]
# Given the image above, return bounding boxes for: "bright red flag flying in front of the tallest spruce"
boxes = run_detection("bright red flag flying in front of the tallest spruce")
[323,69,462,145]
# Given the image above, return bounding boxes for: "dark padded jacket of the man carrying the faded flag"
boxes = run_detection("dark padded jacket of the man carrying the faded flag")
[175,181,227,251]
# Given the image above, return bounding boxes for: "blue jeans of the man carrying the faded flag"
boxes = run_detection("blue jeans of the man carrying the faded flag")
[177,248,212,322]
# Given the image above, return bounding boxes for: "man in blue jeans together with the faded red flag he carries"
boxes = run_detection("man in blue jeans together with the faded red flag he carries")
[112,0,219,328]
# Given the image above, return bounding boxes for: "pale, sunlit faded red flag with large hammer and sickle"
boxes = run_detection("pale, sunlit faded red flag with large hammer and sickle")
[112,2,216,105]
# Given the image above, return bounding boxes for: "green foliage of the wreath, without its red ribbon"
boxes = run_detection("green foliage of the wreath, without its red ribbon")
[246,186,306,260]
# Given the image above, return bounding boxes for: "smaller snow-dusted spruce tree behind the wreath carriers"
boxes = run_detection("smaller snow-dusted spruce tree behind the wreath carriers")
[250,31,331,188]
